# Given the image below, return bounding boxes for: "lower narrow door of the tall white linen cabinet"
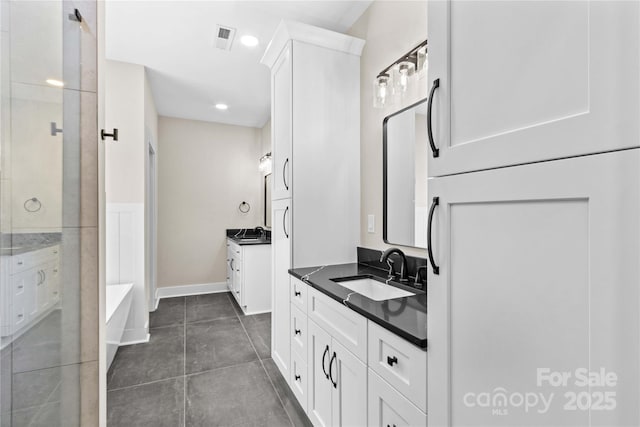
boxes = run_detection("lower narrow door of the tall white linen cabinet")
[271,199,291,381]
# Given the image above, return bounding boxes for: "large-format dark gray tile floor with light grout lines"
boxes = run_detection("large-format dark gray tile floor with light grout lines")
[107,293,311,427]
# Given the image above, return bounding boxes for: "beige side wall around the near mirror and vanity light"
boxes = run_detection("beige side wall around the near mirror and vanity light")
[348,0,427,257]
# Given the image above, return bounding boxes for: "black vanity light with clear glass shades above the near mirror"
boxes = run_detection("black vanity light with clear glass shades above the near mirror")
[373,40,427,108]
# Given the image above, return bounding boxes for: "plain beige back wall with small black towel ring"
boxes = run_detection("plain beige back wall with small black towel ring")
[158,117,263,287]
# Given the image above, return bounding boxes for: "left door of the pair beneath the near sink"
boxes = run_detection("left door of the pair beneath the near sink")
[307,320,333,427]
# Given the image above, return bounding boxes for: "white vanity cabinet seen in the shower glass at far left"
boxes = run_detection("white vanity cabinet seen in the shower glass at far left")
[1,245,61,338]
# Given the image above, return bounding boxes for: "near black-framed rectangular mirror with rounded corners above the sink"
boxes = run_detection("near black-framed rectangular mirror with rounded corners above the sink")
[383,99,428,248]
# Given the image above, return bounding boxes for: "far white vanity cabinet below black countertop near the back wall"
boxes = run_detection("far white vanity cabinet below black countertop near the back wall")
[227,239,271,314]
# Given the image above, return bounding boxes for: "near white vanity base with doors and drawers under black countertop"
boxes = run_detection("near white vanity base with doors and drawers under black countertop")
[290,277,427,426]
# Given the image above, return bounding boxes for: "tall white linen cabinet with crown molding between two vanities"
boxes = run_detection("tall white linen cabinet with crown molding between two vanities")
[261,21,364,381]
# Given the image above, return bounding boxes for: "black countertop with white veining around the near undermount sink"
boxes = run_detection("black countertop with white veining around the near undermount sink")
[289,263,427,350]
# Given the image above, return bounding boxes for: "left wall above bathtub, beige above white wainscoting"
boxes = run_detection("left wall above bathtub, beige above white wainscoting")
[105,61,158,342]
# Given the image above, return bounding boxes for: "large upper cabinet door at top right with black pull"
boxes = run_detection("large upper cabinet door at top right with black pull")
[428,0,640,176]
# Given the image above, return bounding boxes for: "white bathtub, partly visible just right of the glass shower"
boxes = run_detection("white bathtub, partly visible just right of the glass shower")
[106,283,133,369]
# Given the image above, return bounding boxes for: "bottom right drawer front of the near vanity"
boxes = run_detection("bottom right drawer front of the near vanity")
[368,369,427,427]
